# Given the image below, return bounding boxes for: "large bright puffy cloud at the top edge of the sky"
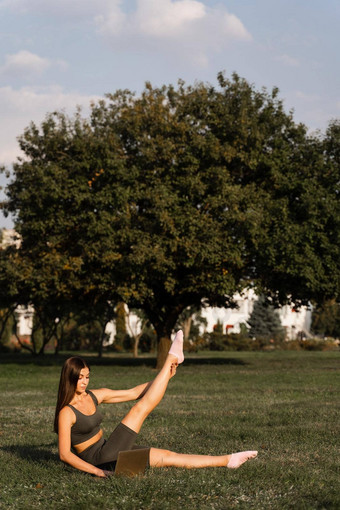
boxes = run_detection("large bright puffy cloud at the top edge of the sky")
[95,0,252,66]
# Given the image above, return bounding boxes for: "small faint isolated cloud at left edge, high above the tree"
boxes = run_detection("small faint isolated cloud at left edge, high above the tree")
[0,50,51,77]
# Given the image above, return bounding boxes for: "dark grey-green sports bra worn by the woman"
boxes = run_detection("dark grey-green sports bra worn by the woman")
[68,391,103,446]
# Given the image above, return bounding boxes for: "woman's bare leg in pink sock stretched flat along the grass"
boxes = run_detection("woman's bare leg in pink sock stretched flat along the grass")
[150,448,257,469]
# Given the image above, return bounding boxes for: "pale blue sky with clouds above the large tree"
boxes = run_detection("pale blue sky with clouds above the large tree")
[0,0,340,228]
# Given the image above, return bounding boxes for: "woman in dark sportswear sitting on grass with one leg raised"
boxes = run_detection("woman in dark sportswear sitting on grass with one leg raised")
[54,331,257,477]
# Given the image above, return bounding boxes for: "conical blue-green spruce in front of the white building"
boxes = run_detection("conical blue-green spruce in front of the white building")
[247,296,285,341]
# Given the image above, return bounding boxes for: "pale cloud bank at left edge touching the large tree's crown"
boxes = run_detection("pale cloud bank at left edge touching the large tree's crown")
[0,86,102,165]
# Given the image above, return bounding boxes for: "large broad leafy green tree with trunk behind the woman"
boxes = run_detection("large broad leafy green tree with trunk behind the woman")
[1,74,339,365]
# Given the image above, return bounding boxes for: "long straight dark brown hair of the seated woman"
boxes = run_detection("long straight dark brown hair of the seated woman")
[54,356,90,434]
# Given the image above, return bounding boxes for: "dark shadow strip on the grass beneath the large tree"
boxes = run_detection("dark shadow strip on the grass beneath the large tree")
[0,352,248,368]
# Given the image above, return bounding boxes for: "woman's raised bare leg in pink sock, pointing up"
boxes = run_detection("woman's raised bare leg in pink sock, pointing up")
[122,331,183,433]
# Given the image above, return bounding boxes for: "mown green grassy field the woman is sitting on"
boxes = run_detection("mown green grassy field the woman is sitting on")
[0,352,340,510]
